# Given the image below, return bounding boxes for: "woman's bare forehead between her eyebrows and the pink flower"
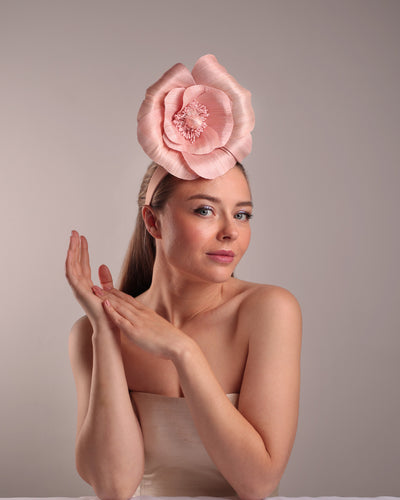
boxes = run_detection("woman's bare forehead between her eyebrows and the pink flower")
[172,167,251,202]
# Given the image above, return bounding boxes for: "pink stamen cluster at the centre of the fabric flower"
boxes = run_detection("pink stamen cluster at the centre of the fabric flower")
[172,99,209,144]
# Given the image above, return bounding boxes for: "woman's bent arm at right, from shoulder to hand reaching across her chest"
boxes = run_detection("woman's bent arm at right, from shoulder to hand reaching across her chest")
[94,287,302,500]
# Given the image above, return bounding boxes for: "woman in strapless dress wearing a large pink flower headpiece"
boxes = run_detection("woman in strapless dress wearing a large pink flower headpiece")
[66,55,302,499]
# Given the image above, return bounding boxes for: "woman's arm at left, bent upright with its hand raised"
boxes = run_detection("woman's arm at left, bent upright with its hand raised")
[66,234,144,500]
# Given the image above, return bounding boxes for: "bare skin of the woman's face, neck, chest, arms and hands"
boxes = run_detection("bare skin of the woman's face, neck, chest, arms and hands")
[66,168,302,499]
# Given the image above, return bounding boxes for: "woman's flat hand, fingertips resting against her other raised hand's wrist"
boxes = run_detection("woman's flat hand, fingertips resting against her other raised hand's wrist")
[92,278,190,360]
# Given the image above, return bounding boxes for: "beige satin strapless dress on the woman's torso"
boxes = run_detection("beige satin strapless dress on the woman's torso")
[130,392,278,499]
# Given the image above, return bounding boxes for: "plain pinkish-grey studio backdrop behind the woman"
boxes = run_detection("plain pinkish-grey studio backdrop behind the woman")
[0,0,400,496]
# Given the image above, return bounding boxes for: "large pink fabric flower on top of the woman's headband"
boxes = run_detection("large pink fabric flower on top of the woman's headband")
[137,54,254,179]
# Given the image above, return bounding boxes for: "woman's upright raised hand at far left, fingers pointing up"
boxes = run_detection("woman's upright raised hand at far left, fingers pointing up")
[65,230,115,330]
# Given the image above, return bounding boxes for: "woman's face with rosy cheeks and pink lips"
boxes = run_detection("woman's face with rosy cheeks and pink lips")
[157,167,252,282]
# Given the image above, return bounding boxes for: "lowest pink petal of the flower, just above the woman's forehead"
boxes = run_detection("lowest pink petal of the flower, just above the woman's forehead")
[182,148,236,179]
